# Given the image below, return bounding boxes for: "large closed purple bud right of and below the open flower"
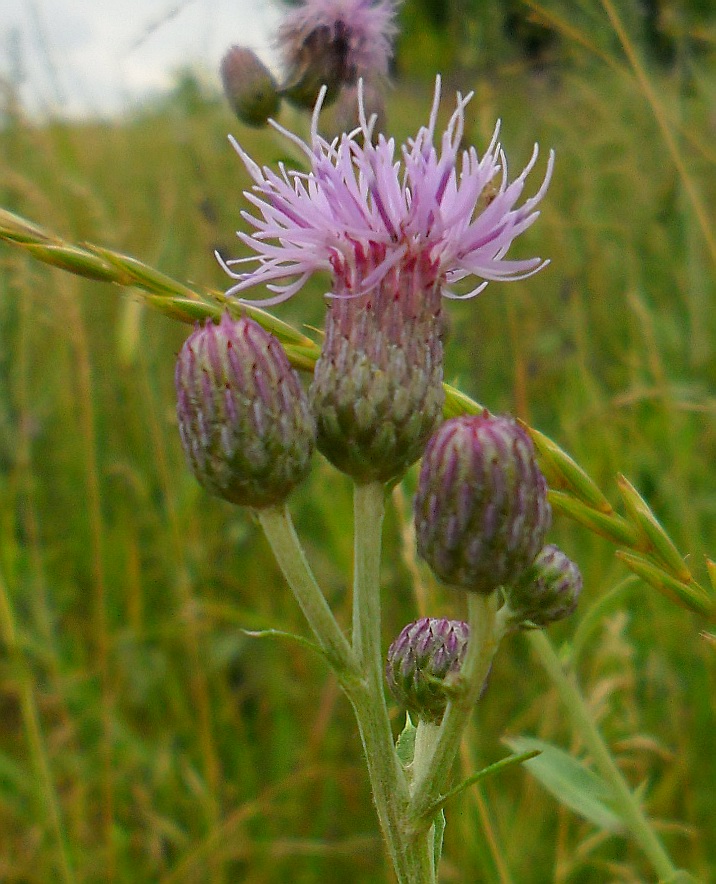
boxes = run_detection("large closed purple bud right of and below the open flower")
[415,412,551,594]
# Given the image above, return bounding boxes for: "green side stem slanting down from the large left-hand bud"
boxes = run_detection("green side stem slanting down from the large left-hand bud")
[257,504,358,687]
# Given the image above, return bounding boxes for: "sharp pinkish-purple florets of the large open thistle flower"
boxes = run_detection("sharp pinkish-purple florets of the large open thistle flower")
[217,78,554,305]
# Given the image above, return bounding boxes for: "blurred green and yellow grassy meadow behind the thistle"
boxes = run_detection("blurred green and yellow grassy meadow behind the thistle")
[0,0,716,884]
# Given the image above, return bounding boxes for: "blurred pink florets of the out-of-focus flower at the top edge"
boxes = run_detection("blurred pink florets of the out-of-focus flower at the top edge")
[278,0,397,82]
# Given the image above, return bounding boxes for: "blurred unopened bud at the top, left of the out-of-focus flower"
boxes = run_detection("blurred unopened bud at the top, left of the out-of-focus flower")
[221,46,281,126]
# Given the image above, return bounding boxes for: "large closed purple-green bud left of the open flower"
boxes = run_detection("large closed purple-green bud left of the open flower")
[175,313,315,509]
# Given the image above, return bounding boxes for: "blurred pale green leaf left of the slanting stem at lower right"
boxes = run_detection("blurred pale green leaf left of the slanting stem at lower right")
[503,737,624,832]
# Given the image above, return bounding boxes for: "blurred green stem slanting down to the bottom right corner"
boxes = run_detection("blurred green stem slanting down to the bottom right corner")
[528,630,676,879]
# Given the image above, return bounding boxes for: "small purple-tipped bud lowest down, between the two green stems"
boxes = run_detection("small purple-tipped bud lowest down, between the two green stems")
[386,617,470,724]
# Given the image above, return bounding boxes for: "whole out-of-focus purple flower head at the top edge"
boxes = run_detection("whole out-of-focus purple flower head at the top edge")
[277,0,397,108]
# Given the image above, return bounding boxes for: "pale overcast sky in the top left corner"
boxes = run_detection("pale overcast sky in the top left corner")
[0,0,279,116]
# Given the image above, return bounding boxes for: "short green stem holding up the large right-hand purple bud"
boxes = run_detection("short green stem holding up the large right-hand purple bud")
[408,592,504,831]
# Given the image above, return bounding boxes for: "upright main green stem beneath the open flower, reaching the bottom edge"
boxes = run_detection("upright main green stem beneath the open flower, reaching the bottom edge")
[347,483,434,884]
